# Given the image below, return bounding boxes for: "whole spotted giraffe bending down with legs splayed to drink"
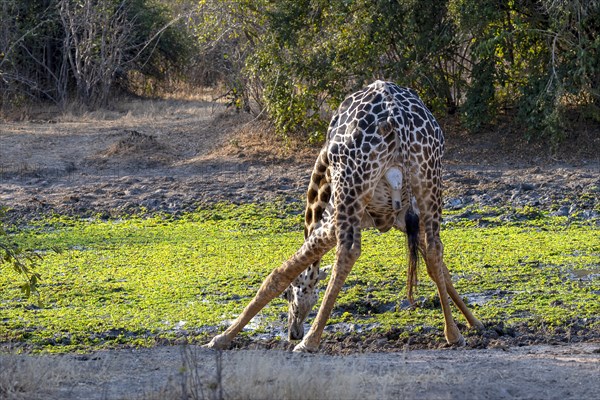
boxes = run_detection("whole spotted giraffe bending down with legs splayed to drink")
[206,80,483,352]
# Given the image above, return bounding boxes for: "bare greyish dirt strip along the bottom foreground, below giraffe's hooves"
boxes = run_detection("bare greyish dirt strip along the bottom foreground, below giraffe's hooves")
[0,343,600,400]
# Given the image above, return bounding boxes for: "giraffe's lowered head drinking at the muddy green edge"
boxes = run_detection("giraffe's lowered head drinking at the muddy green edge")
[283,263,327,340]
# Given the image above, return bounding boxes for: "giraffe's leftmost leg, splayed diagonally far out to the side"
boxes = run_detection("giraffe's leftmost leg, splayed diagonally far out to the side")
[204,226,334,349]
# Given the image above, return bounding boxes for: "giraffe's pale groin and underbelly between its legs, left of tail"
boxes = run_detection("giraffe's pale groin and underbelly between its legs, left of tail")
[362,168,408,232]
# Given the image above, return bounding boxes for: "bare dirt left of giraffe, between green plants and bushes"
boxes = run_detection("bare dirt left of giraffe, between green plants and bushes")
[0,102,312,219]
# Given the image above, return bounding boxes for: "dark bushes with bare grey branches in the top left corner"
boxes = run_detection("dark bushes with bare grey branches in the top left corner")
[0,0,191,107]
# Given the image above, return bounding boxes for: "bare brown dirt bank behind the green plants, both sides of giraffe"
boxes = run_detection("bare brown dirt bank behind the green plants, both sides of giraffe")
[0,100,600,221]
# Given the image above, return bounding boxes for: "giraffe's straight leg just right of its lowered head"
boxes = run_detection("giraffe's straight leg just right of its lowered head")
[294,227,361,353]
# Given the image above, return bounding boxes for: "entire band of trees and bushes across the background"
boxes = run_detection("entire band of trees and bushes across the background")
[0,0,600,145]
